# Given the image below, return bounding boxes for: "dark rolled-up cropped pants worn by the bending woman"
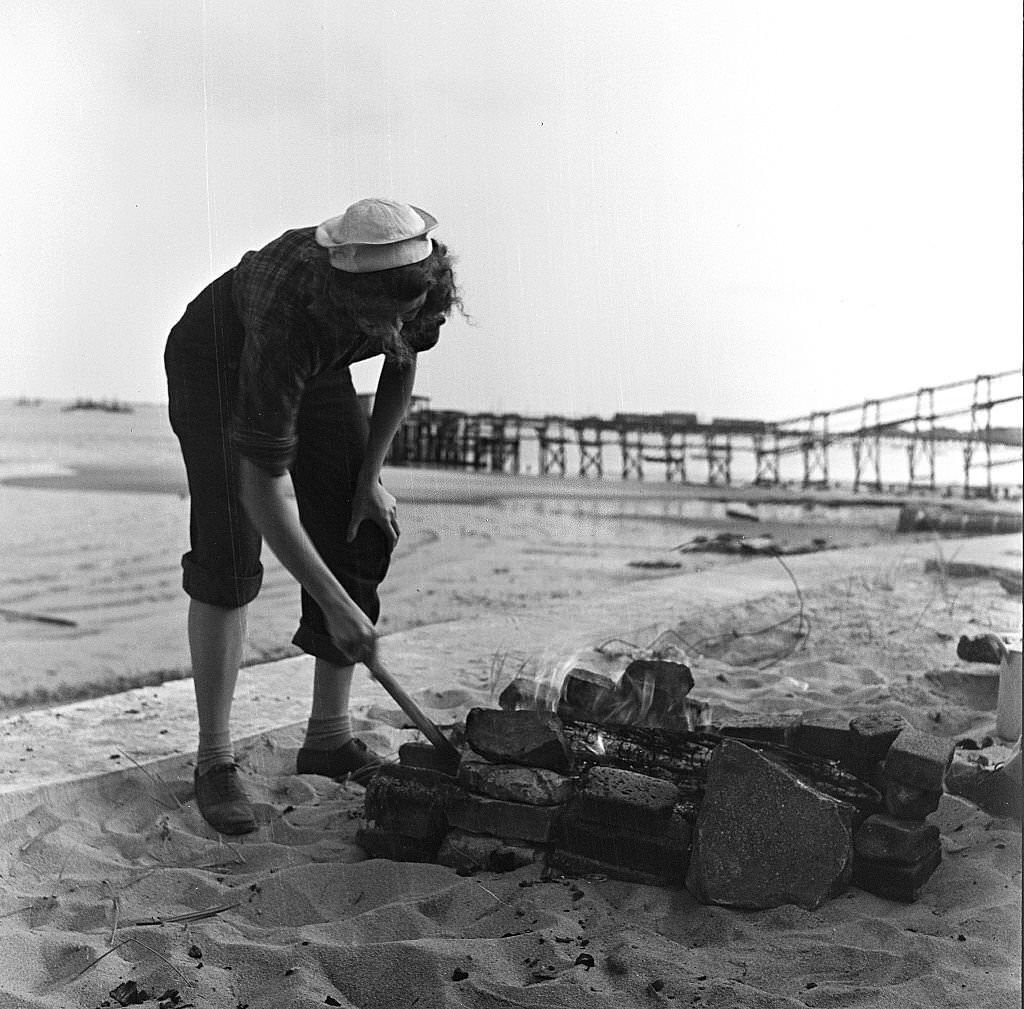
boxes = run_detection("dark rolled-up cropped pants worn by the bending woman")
[164,270,389,665]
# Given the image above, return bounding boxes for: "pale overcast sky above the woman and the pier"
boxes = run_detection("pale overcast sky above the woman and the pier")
[0,0,1022,419]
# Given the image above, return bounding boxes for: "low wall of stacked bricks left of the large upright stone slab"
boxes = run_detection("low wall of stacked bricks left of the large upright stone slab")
[356,708,690,883]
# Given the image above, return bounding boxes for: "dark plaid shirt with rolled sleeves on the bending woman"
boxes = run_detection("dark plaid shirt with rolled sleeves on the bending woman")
[231,227,442,475]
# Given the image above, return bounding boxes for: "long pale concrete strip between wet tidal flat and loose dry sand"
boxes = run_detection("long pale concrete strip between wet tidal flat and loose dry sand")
[0,535,1021,819]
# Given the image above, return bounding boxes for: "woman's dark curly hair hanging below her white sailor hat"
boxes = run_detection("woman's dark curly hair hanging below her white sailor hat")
[317,239,462,352]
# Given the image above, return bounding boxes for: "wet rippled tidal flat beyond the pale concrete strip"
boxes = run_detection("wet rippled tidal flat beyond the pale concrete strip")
[0,404,921,710]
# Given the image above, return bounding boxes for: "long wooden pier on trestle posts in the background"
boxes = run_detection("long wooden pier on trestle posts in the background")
[388,369,1022,498]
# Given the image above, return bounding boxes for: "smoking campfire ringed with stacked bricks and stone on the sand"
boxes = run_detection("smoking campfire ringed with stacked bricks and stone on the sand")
[357,641,952,909]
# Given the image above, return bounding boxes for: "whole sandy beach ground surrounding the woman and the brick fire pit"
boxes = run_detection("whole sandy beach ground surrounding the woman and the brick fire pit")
[0,397,1021,1009]
